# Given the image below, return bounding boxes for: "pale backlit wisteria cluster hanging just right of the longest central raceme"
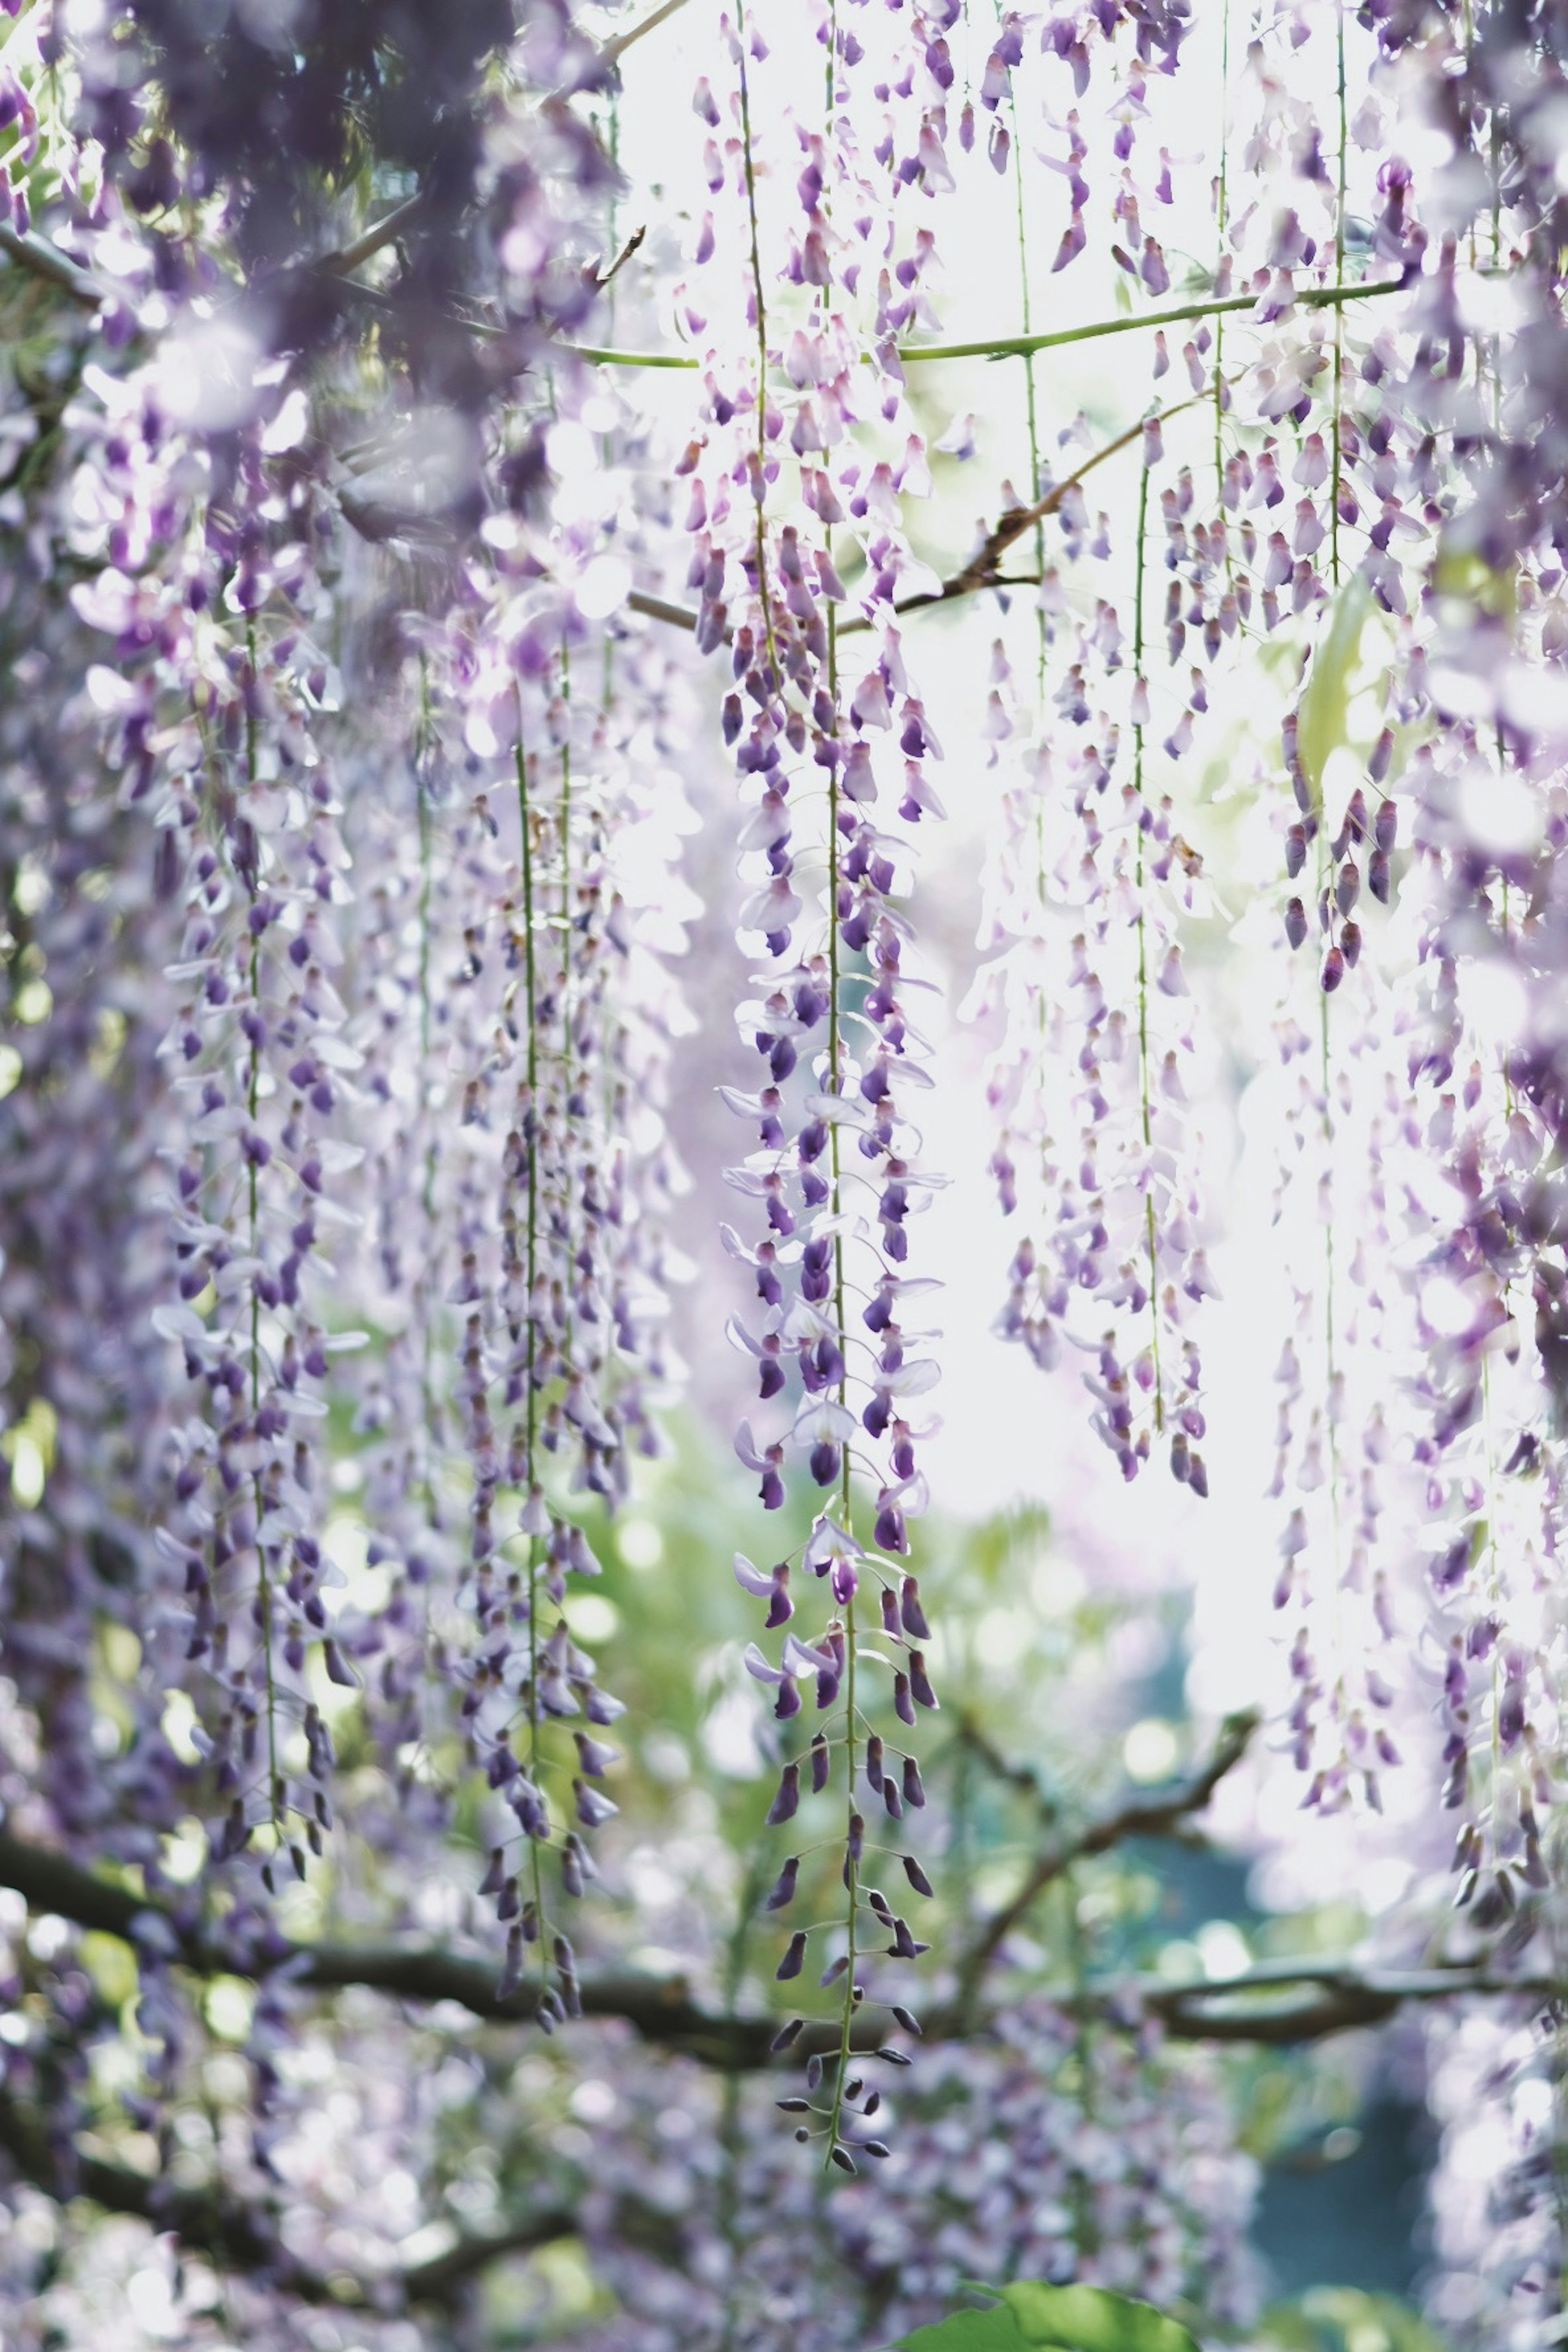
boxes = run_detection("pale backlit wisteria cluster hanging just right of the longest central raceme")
[976,19,1236,1496]
